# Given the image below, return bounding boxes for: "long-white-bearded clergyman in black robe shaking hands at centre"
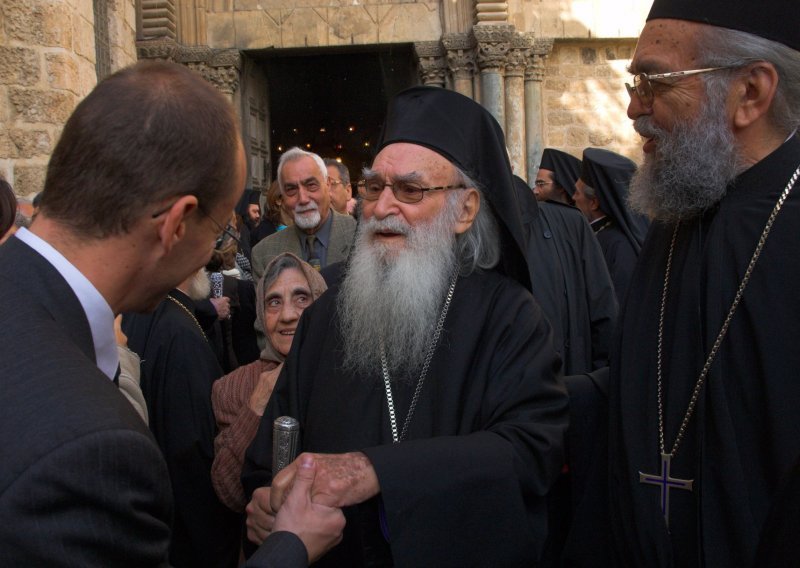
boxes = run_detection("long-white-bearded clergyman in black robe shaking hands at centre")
[243,87,567,566]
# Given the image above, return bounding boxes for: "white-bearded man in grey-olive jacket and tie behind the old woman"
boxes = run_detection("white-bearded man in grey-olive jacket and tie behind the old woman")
[252,148,356,281]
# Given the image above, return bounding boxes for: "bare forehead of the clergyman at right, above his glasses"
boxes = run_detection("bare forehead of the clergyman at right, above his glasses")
[630,19,707,73]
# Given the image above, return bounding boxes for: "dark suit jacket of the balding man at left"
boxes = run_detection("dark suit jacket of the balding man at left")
[0,237,172,568]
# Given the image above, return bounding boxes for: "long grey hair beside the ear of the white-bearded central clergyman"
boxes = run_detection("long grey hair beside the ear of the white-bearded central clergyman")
[448,164,500,276]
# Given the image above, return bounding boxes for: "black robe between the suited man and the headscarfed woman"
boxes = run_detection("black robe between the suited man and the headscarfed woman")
[122,290,242,568]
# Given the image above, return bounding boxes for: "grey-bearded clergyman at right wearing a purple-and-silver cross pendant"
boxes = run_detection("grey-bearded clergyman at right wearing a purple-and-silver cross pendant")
[609,0,800,566]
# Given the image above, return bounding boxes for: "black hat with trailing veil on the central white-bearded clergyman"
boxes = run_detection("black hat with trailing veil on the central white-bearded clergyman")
[377,87,531,290]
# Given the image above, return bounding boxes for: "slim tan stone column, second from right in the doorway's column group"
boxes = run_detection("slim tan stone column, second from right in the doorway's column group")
[505,34,531,179]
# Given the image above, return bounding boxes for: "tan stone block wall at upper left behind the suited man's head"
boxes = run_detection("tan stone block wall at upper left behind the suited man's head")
[0,0,136,195]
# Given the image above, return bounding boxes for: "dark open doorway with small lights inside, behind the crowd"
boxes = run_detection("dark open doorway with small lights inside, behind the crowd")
[255,45,418,184]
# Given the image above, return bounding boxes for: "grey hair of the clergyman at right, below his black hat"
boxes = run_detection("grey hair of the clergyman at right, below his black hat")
[698,26,800,135]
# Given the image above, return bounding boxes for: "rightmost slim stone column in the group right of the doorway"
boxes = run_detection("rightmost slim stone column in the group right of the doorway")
[525,39,553,185]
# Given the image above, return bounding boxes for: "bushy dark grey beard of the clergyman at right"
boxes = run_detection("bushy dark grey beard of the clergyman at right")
[628,91,744,222]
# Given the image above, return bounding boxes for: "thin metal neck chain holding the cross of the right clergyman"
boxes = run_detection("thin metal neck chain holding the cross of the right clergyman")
[657,166,800,457]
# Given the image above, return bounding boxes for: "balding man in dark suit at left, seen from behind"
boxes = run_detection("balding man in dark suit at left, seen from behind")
[0,62,335,567]
